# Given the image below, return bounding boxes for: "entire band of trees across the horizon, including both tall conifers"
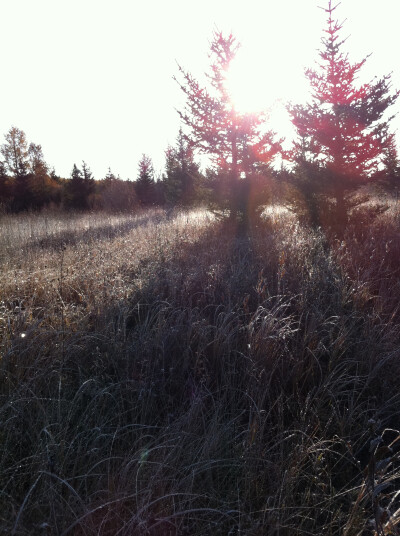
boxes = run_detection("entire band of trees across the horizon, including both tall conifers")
[0,2,400,234]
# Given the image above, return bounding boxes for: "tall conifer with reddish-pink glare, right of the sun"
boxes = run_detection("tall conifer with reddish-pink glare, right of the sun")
[289,0,398,227]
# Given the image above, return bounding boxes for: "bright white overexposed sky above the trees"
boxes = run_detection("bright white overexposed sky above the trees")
[0,0,400,179]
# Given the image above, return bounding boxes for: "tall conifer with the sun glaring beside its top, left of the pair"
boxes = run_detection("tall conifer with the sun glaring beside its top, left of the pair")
[175,33,281,224]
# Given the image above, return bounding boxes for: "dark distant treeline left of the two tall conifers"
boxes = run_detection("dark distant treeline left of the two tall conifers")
[0,126,212,212]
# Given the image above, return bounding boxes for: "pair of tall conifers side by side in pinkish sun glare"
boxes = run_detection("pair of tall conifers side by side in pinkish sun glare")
[172,0,400,232]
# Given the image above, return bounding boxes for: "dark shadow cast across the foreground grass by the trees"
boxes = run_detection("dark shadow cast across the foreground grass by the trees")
[0,218,400,536]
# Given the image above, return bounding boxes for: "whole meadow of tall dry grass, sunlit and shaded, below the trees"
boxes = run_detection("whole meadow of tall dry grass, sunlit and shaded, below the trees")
[0,204,400,536]
